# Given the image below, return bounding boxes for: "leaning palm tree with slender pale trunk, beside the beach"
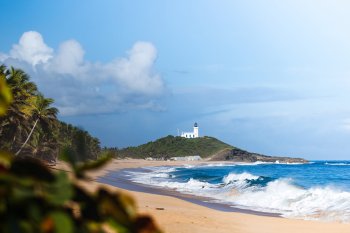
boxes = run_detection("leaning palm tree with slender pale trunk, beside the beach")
[15,93,58,155]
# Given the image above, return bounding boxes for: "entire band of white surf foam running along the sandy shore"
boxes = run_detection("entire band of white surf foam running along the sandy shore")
[132,167,350,222]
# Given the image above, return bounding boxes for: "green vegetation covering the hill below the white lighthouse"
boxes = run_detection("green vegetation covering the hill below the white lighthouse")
[115,135,234,159]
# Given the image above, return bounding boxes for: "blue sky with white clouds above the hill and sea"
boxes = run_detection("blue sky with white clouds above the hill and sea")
[0,0,350,160]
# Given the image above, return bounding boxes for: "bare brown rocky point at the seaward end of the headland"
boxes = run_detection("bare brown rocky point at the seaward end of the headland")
[209,148,308,163]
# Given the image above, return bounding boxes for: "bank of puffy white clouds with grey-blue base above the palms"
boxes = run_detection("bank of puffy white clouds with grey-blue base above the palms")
[0,31,165,115]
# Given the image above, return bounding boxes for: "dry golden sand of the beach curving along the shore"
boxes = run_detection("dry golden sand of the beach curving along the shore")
[57,160,350,233]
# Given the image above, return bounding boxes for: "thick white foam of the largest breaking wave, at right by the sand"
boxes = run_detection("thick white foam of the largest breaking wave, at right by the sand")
[228,179,350,222]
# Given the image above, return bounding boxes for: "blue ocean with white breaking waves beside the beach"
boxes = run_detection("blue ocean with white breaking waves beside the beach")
[127,161,350,223]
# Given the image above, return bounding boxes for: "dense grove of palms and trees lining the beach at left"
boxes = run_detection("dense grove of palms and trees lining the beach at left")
[0,65,100,161]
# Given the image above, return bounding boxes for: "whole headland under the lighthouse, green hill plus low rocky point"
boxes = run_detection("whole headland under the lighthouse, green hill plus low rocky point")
[110,135,307,163]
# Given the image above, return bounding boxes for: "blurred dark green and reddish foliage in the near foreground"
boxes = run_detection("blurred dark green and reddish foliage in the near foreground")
[0,153,159,233]
